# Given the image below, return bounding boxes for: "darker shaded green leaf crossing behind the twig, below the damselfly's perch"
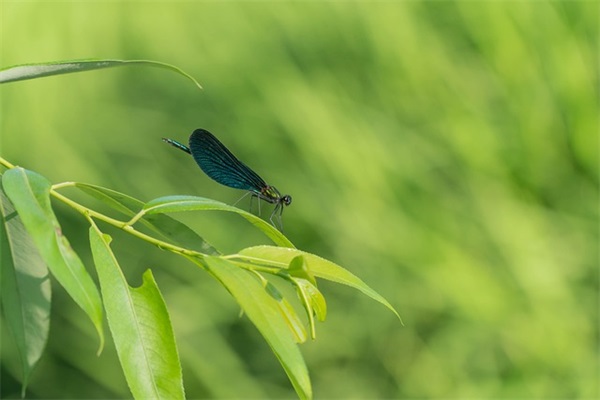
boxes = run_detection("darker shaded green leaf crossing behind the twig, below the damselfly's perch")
[75,183,219,255]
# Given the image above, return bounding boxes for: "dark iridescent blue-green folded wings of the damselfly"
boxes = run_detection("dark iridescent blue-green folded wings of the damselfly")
[190,129,267,192]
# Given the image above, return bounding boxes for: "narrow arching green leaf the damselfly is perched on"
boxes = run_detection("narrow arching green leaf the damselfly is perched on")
[144,196,294,247]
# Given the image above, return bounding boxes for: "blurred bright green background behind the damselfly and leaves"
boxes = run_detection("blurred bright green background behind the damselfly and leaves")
[0,1,600,399]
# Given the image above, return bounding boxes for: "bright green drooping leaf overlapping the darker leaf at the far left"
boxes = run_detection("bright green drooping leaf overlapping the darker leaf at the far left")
[2,168,104,353]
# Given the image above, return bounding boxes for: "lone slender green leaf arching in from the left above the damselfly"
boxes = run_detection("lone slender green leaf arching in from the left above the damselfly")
[0,59,202,89]
